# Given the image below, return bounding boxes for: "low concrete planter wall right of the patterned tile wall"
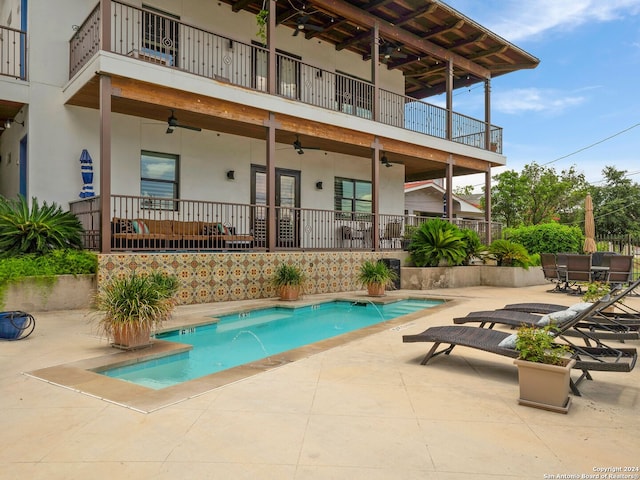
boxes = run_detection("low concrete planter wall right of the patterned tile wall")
[401,265,547,290]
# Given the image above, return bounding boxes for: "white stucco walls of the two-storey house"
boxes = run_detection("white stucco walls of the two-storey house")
[0,0,404,213]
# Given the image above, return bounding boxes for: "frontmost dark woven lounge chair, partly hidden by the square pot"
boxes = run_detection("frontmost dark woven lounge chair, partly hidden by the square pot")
[402,302,638,395]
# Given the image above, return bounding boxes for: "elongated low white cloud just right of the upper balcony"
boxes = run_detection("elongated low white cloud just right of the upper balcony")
[492,88,586,115]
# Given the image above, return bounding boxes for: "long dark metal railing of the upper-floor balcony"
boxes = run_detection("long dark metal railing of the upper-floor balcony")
[69,0,516,153]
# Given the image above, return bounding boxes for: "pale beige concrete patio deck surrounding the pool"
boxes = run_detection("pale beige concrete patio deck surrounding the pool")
[0,285,640,480]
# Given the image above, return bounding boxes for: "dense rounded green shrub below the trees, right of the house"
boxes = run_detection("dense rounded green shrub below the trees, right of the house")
[503,223,584,253]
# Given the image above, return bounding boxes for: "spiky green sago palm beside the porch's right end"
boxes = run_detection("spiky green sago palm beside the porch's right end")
[408,218,467,267]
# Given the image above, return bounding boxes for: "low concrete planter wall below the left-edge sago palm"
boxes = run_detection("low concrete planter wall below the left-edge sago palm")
[1,275,96,312]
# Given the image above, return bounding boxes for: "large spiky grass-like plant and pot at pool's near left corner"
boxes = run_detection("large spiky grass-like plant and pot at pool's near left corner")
[95,272,178,350]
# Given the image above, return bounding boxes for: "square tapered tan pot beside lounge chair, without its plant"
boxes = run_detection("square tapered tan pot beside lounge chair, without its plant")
[513,359,576,413]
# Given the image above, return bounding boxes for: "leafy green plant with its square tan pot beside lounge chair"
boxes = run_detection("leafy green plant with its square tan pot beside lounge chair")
[514,325,576,413]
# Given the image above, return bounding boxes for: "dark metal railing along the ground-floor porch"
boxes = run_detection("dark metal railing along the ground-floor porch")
[70,195,501,252]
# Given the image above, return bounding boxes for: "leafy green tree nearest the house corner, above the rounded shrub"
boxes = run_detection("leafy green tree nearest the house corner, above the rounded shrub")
[491,163,588,227]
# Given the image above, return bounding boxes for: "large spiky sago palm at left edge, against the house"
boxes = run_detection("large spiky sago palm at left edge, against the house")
[0,195,82,257]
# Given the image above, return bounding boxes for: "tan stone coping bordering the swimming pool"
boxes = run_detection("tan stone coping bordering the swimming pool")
[25,294,456,413]
